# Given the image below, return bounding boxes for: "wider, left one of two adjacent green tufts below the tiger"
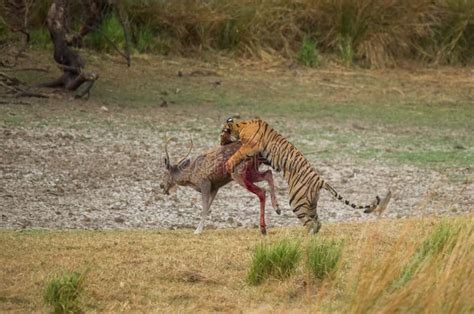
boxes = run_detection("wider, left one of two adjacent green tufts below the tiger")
[247,240,301,285]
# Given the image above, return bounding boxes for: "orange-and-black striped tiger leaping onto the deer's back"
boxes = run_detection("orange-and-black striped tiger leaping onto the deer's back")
[223,118,391,234]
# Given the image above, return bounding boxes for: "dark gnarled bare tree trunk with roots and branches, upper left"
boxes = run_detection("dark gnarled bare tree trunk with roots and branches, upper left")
[0,0,130,97]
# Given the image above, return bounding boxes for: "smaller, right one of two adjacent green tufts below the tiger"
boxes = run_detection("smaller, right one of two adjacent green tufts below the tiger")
[306,238,342,279]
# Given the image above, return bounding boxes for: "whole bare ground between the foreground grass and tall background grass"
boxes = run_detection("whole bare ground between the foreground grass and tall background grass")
[0,51,474,229]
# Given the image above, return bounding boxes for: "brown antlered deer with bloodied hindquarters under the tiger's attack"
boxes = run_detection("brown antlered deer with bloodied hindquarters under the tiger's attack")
[160,129,281,235]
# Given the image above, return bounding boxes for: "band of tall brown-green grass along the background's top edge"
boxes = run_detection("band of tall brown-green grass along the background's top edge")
[17,0,474,67]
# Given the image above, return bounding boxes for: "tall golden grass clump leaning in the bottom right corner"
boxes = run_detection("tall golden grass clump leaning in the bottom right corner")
[341,217,474,313]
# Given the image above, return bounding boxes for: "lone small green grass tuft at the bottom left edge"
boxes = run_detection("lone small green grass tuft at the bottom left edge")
[44,272,84,313]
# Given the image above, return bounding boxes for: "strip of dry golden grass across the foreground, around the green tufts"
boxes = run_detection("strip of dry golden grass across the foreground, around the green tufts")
[0,217,474,313]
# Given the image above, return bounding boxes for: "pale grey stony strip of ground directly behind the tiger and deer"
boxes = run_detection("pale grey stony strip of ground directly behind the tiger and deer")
[0,118,474,233]
